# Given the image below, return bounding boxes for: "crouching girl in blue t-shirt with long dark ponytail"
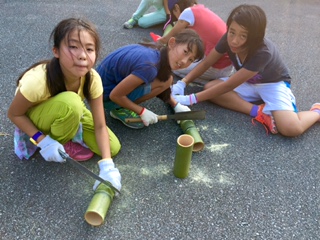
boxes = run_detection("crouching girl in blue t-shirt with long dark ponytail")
[97,29,204,129]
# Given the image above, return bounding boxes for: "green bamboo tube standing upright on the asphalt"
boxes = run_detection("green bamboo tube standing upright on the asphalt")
[173,134,194,178]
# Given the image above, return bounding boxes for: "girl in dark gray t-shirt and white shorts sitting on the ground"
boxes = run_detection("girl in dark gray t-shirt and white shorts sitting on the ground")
[172,4,320,137]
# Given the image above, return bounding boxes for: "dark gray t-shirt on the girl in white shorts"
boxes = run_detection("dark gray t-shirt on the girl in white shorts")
[215,33,291,83]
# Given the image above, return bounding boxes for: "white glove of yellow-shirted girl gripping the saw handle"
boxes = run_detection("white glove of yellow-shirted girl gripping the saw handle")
[37,135,66,163]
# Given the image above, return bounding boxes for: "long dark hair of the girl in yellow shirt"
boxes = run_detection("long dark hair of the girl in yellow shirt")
[17,18,101,100]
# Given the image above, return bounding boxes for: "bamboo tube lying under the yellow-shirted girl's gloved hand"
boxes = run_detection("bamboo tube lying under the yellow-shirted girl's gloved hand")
[84,184,114,226]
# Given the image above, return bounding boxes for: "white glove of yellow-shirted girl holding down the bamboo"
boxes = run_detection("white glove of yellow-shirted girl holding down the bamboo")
[93,159,121,191]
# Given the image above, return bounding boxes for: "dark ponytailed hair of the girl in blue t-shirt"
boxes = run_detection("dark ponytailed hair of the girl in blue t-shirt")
[140,28,204,82]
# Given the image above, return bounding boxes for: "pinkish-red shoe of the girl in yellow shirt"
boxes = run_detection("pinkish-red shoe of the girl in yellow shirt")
[63,141,94,162]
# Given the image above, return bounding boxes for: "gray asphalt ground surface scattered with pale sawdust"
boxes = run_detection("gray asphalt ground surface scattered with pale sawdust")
[0,0,320,240]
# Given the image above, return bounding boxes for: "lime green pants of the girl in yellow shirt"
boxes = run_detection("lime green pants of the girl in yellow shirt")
[27,92,121,156]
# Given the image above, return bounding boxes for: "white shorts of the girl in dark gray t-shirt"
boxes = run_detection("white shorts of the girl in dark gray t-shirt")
[222,78,298,115]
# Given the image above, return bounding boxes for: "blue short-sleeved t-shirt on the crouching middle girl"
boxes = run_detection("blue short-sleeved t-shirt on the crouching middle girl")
[97,44,160,99]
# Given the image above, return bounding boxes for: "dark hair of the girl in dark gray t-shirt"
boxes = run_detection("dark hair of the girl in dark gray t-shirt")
[227,4,267,59]
